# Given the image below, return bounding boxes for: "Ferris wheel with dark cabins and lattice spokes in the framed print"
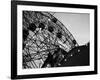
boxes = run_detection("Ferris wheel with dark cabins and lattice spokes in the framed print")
[23,11,78,69]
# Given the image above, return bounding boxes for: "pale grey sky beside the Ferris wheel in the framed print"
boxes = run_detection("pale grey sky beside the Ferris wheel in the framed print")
[54,12,90,45]
